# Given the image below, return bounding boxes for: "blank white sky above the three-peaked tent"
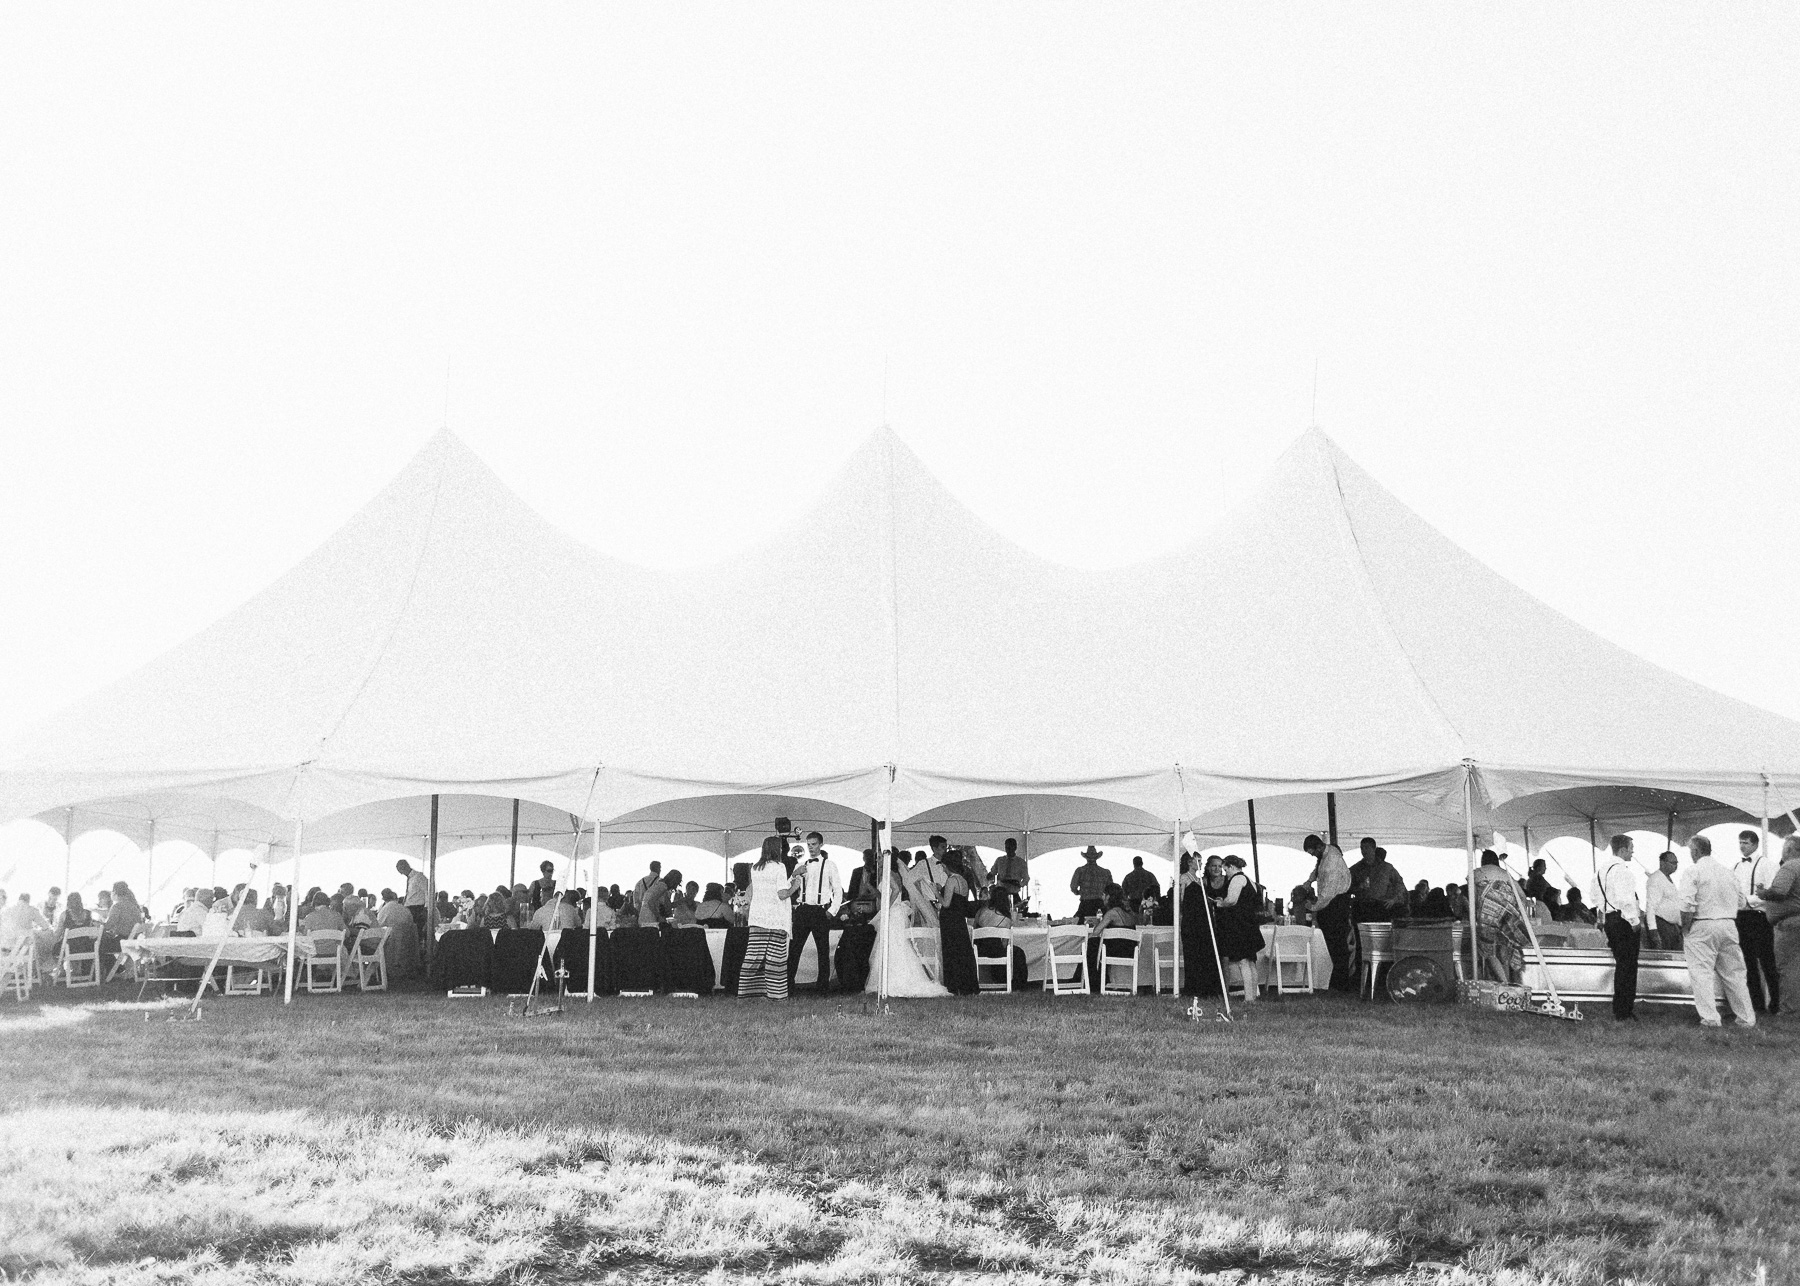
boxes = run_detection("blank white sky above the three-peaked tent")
[0,4,1800,900]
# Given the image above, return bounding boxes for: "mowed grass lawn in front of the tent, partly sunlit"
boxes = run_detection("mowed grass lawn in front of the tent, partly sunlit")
[0,992,1800,1282]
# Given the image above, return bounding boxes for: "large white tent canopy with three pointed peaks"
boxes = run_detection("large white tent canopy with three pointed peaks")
[0,430,1800,848]
